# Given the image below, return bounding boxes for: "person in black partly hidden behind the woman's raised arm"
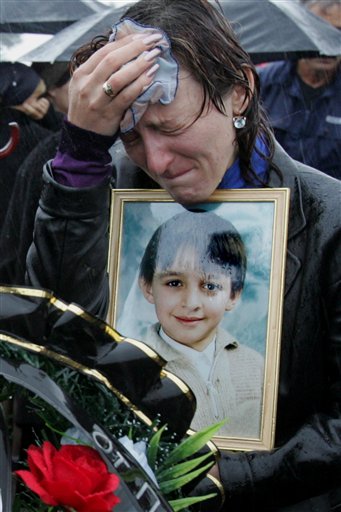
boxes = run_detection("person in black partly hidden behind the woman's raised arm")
[0,63,70,285]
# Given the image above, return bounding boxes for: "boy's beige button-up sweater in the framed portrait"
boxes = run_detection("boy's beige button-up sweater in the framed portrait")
[144,323,264,438]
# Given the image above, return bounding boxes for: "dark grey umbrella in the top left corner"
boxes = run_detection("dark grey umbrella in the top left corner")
[0,0,104,34]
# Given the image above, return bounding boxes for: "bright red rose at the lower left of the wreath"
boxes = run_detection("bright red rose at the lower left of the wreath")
[16,441,120,512]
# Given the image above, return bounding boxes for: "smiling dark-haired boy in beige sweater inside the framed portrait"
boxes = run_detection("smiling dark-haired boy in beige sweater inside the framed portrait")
[139,211,264,438]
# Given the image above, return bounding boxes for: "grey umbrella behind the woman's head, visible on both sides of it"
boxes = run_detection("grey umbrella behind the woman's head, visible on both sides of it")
[20,0,341,64]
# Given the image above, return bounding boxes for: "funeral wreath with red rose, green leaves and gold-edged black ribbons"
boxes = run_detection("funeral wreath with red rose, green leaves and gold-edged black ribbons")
[0,287,221,512]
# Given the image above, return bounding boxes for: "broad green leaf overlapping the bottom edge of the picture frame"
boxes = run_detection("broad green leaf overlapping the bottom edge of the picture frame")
[163,420,226,467]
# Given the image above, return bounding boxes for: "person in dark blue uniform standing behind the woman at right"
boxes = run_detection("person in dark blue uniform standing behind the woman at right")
[259,0,341,179]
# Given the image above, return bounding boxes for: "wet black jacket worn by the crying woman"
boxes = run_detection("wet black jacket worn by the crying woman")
[27,145,341,512]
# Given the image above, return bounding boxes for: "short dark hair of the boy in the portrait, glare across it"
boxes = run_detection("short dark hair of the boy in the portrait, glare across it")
[139,211,247,294]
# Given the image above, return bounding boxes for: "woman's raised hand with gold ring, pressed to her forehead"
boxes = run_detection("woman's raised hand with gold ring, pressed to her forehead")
[68,33,162,135]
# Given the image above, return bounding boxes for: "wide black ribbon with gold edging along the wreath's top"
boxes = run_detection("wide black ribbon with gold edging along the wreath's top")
[0,286,196,439]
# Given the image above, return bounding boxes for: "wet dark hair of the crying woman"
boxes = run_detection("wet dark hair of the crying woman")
[72,0,273,185]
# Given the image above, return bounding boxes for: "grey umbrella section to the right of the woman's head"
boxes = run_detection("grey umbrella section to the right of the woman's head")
[220,0,341,63]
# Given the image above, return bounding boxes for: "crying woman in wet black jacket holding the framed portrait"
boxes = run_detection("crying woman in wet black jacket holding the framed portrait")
[26,0,341,512]
